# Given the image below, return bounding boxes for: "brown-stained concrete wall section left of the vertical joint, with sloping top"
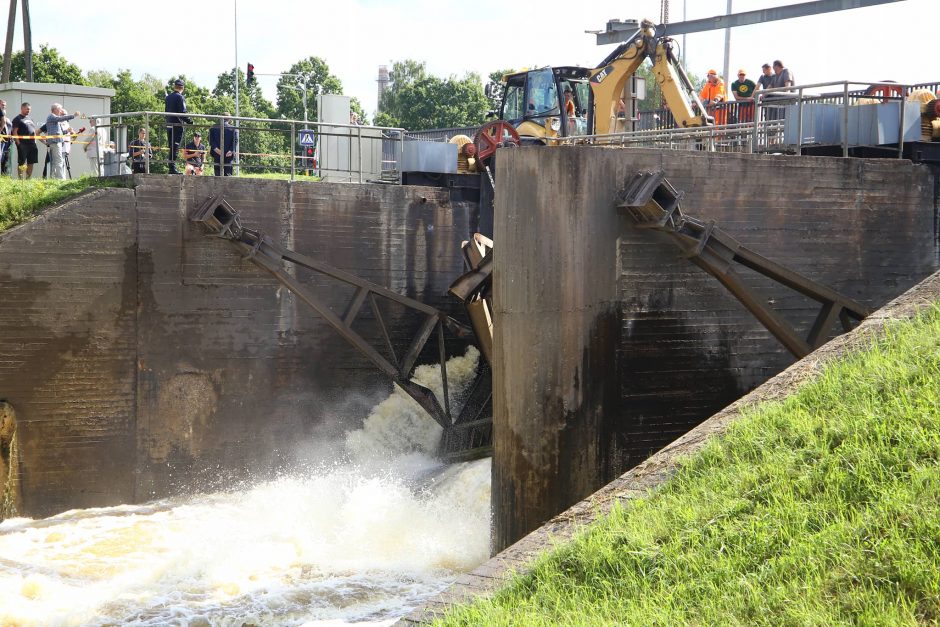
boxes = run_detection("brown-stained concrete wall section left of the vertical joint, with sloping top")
[0,189,137,514]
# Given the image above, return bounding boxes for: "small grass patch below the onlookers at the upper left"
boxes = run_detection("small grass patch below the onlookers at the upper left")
[0,176,127,231]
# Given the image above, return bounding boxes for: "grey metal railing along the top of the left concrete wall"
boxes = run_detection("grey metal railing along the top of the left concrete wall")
[90,111,404,183]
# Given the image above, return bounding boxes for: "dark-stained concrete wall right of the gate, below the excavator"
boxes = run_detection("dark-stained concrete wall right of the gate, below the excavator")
[493,147,938,549]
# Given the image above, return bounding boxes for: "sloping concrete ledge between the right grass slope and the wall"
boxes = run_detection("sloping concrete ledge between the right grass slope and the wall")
[397,272,940,626]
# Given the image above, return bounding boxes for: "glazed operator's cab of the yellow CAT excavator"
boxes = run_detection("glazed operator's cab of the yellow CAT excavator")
[499,66,594,143]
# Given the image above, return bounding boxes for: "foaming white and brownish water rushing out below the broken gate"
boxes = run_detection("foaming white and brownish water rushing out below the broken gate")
[0,349,490,625]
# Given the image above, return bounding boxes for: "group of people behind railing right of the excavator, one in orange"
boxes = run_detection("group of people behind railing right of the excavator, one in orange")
[699,60,794,124]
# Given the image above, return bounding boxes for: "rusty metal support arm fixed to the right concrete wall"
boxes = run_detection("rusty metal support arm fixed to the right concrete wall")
[617,171,871,359]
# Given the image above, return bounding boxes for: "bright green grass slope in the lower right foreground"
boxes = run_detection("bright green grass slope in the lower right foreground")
[439,304,940,626]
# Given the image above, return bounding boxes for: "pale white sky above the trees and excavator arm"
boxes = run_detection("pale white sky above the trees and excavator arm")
[0,0,940,115]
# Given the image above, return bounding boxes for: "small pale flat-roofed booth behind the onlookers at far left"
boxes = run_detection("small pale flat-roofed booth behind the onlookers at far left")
[0,83,114,178]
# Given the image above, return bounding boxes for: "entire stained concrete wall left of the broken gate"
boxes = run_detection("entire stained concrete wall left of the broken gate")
[0,176,469,516]
